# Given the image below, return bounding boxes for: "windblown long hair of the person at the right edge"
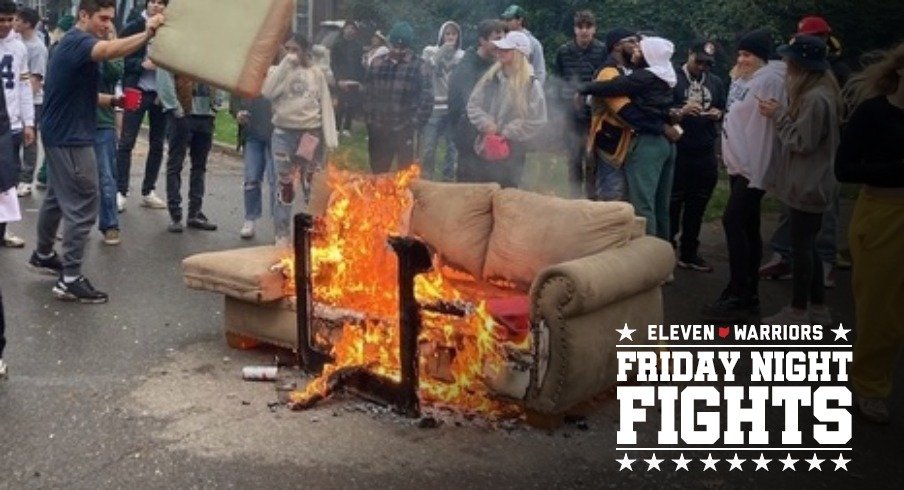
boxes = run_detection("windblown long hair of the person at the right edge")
[844,42,904,114]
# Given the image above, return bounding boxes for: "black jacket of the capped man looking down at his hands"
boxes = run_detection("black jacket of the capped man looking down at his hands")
[674,67,726,150]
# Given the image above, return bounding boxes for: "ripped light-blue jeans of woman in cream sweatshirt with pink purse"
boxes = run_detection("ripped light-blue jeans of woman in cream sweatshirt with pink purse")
[270,128,325,238]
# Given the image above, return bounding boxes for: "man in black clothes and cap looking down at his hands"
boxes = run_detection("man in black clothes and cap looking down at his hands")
[669,41,726,272]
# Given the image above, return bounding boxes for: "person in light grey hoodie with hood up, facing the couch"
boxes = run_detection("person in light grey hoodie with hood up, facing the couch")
[421,20,465,181]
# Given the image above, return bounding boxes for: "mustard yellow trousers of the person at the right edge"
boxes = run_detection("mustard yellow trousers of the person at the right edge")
[849,192,904,398]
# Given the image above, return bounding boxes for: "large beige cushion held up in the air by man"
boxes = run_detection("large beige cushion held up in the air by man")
[150,0,295,97]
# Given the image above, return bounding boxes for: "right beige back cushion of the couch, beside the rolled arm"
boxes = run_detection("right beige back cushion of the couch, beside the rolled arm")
[483,189,634,286]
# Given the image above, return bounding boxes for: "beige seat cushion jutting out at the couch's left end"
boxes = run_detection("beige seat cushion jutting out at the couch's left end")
[182,249,287,303]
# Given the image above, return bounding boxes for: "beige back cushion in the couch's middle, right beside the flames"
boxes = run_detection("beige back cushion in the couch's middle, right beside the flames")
[411,180,500,277]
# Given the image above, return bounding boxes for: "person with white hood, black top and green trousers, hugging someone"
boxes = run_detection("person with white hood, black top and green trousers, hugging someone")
[579,36,677,240]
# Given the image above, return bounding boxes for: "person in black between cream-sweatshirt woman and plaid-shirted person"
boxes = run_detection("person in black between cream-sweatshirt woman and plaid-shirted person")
[330,20,364,136]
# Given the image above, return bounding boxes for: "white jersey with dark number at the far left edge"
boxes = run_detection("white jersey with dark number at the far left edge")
[0,31,35,131]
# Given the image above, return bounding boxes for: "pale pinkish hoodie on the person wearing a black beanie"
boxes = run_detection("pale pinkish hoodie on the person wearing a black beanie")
[722,60,788,190]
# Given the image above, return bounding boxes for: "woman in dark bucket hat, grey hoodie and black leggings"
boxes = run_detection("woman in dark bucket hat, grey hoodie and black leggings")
[759,35,843,325]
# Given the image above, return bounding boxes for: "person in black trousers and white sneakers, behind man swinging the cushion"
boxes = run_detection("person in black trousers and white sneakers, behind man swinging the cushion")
[116,0,169,211]
